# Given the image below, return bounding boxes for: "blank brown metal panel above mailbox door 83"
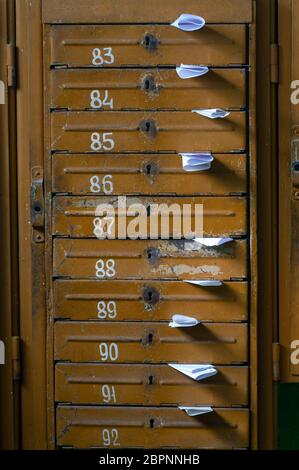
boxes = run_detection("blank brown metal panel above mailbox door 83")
[42,0,252,23]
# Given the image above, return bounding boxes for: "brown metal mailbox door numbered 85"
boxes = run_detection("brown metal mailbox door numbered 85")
[51,111,246,153]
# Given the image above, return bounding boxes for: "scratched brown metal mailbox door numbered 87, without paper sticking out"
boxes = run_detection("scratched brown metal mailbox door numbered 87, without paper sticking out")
[53,196,247,238]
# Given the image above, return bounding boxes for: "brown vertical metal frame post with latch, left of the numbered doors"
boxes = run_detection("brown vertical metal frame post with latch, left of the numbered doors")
[15,0,51,449]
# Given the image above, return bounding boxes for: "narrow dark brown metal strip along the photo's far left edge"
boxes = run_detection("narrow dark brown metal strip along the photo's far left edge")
[0,0,20,450]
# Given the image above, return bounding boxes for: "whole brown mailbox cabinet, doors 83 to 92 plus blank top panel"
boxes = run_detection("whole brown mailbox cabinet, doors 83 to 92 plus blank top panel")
[11,0,257,449]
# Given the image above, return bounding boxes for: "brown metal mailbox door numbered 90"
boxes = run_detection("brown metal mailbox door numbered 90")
[54,321,248,364]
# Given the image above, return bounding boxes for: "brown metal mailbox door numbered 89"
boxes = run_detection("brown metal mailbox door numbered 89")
[53,280,248,322]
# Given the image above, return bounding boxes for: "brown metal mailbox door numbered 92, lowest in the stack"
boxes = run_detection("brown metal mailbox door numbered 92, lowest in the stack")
[56,406,249,449]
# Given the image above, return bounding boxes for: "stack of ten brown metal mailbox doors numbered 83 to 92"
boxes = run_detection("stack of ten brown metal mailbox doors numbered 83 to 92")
[46,13,250,448]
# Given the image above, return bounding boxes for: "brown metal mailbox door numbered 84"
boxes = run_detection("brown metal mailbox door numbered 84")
[50,68,246,111]
